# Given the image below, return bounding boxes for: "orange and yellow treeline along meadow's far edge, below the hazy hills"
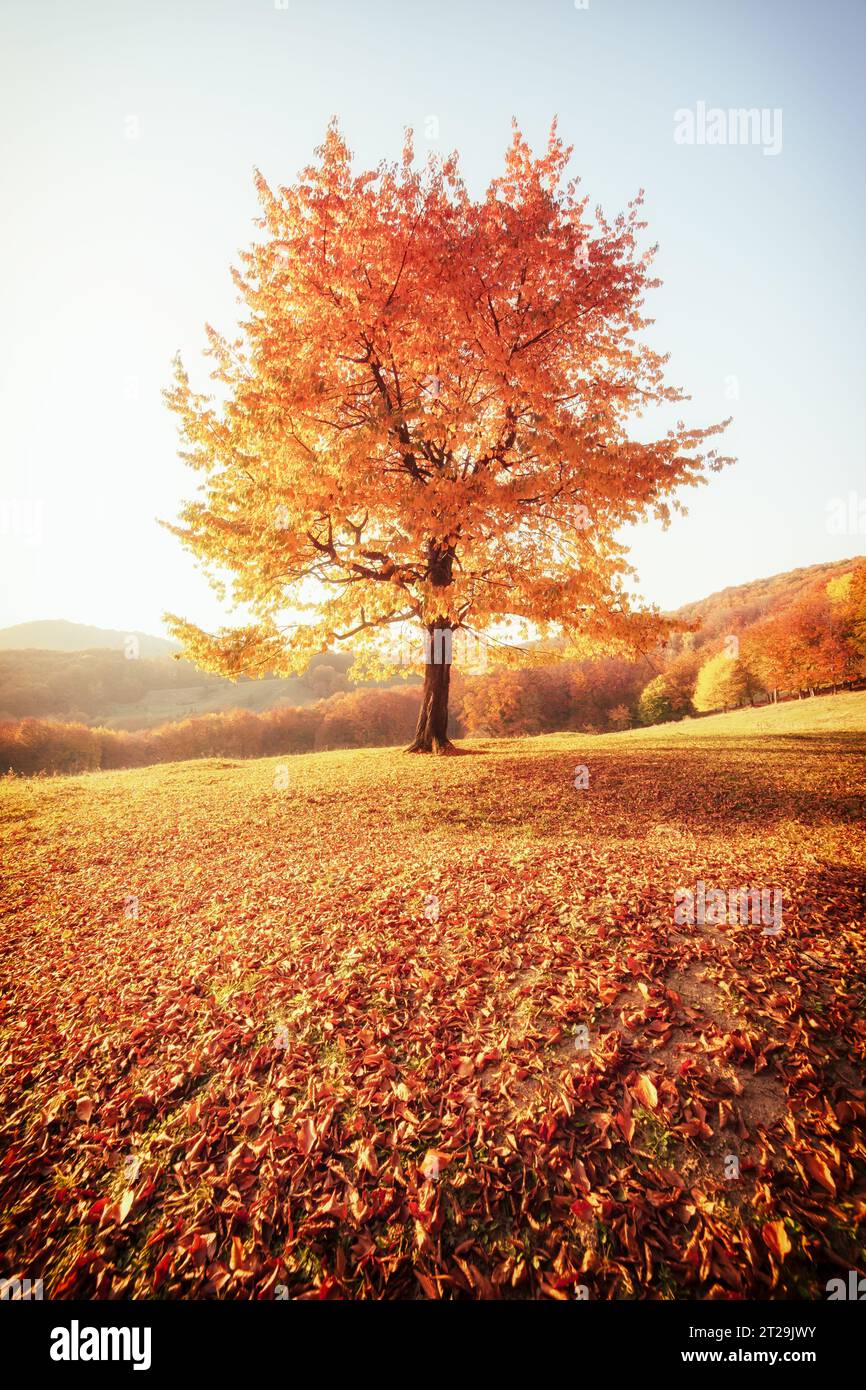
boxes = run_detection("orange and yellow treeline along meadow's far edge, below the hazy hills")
[0,563,866,776]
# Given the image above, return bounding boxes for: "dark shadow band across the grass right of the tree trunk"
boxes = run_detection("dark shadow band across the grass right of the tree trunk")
[402,735,866,841]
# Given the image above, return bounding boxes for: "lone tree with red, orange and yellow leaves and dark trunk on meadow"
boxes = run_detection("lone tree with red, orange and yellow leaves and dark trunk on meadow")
[167,124,727,753]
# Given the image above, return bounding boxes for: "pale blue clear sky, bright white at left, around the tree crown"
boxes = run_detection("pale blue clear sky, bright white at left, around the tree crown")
[0,0,866,632]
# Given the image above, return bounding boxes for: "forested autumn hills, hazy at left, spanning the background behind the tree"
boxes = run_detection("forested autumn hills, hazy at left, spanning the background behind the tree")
[0,559,866,776]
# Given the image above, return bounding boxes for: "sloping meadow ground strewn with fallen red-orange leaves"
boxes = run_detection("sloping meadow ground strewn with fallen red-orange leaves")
[0,695,866,1298]
